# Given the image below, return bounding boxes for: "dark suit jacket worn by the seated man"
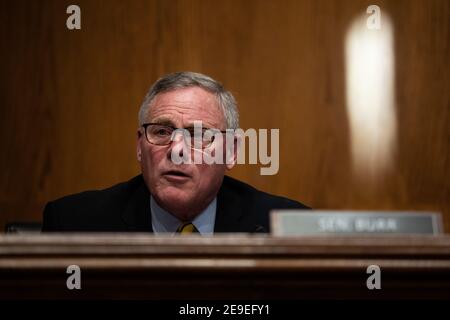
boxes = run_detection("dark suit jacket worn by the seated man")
[42,175,307,233]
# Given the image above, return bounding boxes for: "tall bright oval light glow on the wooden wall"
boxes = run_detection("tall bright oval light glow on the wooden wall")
[345,15,397,181]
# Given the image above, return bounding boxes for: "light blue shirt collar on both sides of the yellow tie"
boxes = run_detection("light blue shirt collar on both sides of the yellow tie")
[150,195,217,235]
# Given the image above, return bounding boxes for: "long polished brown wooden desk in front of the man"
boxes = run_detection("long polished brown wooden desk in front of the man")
[0,234,450,299]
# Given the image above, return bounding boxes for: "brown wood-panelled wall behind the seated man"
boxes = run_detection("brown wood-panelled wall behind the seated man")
[0,0,450,231]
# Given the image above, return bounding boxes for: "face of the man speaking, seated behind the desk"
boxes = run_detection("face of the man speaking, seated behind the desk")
[137,87,233,220]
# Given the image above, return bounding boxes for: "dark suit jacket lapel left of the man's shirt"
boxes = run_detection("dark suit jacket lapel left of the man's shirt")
[122,179,153,232]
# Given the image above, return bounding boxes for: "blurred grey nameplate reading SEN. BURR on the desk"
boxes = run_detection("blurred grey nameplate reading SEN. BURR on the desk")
[270,210,443,236]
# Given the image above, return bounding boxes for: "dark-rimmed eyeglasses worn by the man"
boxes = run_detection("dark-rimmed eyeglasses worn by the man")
[142,123,227,149]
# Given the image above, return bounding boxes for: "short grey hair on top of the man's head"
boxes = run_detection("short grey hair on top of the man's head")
[139,72,239,129]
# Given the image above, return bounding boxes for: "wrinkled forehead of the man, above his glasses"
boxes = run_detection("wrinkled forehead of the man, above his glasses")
[147,87,226,129]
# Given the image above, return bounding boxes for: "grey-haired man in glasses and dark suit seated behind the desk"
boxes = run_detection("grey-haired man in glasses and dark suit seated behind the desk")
[43,72,306,235]
